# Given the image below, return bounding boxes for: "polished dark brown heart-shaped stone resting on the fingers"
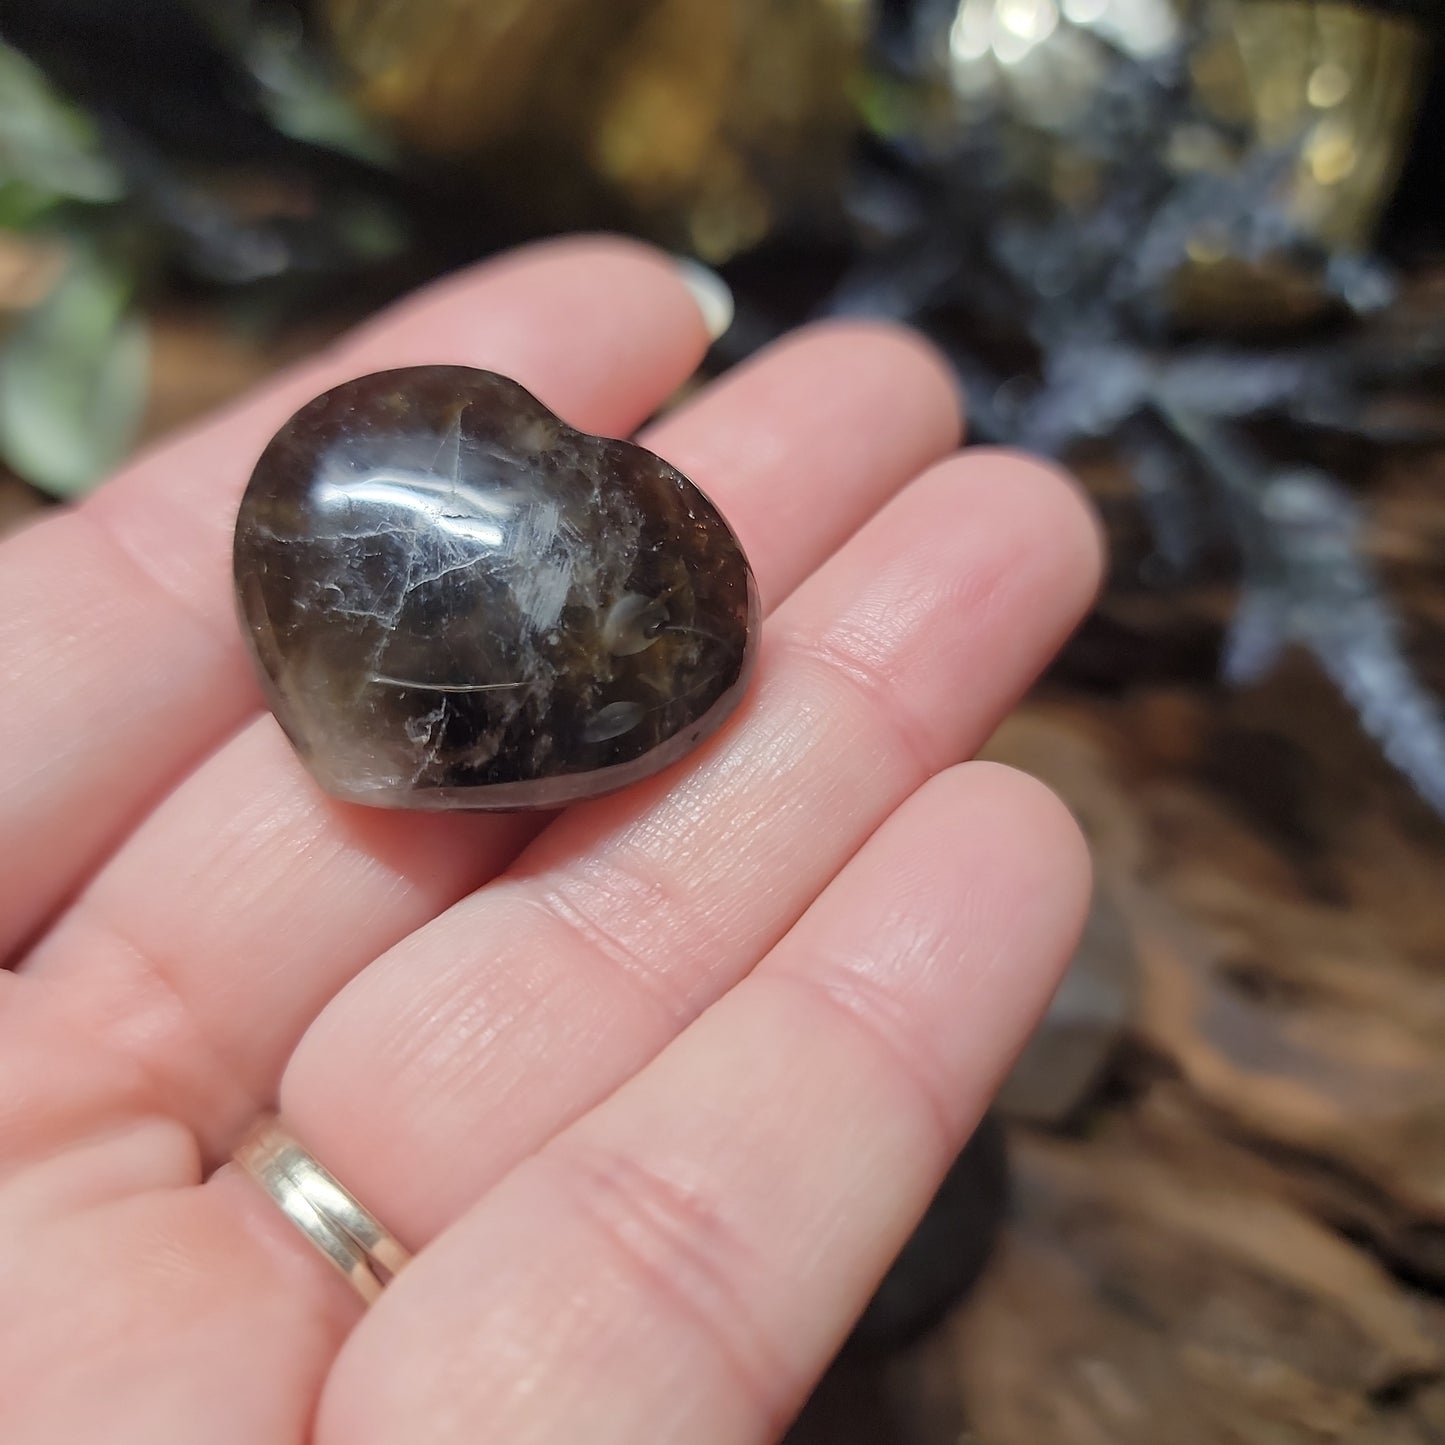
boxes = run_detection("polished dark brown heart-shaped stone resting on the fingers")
[236,366,757,809]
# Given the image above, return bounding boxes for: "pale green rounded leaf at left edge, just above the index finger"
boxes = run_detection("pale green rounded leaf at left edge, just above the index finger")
[0,251,150,497]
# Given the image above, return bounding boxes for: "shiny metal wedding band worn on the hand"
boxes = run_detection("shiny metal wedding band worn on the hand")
[233,1116,410,1305]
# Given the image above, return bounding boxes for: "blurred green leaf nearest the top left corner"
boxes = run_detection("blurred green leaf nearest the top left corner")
[0,42,124,202]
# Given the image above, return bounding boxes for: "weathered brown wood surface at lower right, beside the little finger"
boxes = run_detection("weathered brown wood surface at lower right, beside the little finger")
[795,592,1445,1445]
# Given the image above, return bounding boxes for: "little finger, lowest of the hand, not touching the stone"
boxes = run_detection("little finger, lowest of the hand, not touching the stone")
[316,763,1088,1445]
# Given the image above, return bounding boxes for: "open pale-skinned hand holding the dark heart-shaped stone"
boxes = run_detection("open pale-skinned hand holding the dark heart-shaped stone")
[0,240,1100,1445]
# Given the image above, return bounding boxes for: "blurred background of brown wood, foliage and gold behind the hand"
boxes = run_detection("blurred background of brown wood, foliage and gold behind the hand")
[0,0,1445,1445]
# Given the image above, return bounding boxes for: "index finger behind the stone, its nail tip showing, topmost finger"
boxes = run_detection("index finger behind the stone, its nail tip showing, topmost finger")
[0,238,719,958]
